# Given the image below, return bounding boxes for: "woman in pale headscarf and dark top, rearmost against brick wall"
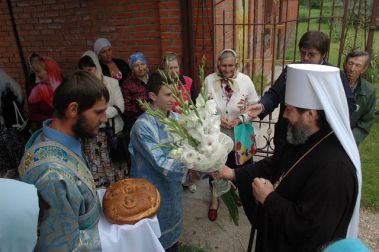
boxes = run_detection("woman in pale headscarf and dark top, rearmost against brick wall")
[93,38,130,86]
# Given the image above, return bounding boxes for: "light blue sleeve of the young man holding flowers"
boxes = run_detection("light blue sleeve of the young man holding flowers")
[131,120,186,181]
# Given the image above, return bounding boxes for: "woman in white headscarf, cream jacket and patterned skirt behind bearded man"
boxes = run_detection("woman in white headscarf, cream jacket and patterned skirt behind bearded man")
[78,51,128,187]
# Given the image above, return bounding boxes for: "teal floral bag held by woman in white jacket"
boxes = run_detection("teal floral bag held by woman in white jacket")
[234,123,256,165]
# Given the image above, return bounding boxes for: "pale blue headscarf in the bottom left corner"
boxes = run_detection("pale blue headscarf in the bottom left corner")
[0,178,39,252]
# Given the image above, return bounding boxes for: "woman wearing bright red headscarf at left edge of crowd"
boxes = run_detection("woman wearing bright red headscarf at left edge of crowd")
[28,58,62,129]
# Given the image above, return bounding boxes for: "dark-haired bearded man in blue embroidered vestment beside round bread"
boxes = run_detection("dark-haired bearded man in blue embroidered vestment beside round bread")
[19,72,109,251]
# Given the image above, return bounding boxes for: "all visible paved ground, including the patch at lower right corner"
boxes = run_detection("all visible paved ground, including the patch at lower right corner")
[180,179,379,252]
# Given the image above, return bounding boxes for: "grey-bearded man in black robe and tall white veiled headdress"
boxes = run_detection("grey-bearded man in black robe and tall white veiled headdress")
[219,64,361,251]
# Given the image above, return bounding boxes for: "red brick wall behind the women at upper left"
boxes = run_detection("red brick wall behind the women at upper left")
[0,0,213,93]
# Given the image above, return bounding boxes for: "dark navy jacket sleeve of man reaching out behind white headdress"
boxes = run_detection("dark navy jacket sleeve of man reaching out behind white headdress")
[259,68,287,120]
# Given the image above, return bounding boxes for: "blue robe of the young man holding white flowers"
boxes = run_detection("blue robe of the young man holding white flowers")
[129,113,187,249]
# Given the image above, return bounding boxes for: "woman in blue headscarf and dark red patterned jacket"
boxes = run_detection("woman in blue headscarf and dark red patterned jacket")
[121,52,149,132]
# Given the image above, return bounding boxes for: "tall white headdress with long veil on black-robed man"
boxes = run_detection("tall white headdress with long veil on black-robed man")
[285,64,362,238]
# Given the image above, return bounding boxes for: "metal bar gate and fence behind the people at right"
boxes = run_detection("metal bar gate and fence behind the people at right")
[213,0,379,156]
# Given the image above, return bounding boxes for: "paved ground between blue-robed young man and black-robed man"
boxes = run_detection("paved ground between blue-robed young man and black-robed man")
[180,179,250,252]
